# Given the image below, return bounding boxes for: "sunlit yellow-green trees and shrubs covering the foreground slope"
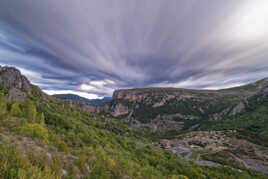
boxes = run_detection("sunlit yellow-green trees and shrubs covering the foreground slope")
[0,91,265,179]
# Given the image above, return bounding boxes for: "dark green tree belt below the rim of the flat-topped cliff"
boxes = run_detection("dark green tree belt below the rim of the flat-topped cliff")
[133,96,237,127]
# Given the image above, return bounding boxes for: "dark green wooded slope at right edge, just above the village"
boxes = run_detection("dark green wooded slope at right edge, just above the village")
[201,89,268,146]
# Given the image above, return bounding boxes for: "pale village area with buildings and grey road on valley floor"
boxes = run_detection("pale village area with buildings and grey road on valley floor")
[161,131,268,174]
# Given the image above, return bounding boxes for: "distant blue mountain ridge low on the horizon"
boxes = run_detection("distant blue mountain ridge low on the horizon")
[52,94,112,105]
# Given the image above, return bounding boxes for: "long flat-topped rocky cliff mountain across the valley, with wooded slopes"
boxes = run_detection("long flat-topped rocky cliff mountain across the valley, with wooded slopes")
[104,79,268,133]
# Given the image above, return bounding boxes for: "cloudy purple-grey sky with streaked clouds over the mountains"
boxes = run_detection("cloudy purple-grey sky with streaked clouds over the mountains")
[0,0,268,98]
